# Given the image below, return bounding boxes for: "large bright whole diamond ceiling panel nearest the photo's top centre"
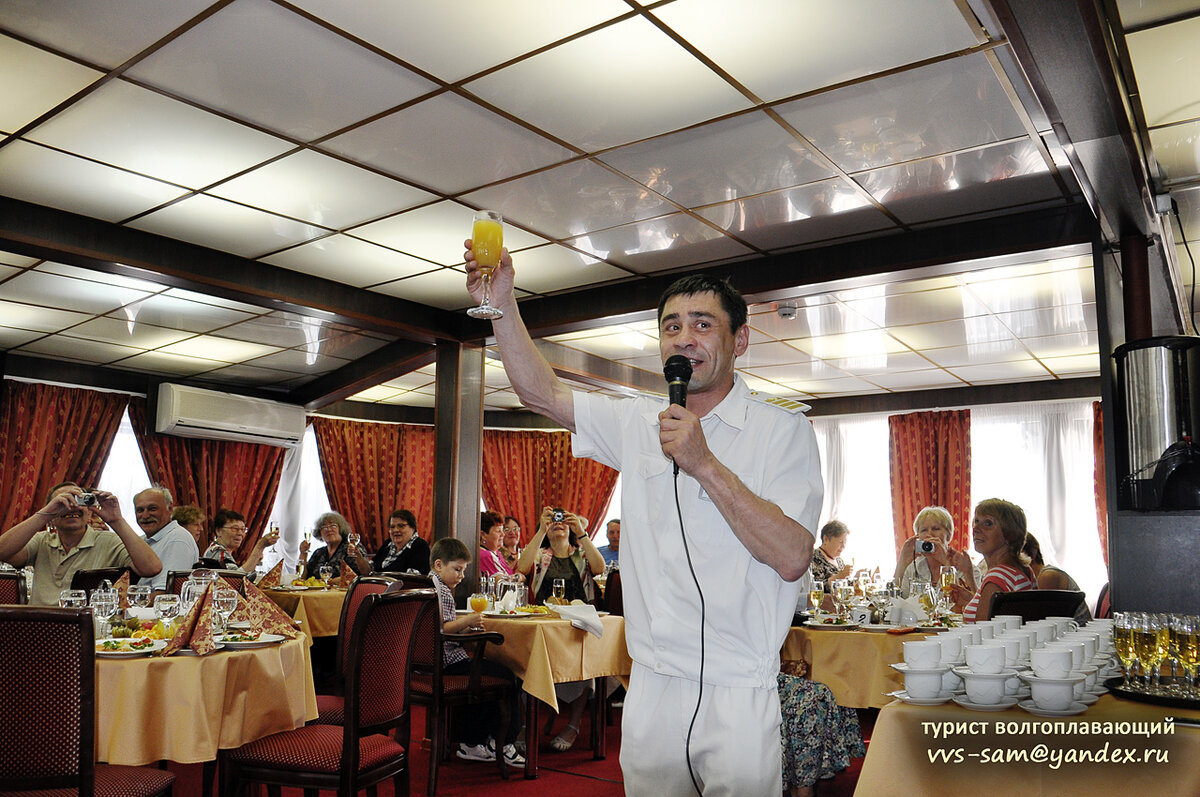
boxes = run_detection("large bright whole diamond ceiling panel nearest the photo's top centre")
[466,18,749,150]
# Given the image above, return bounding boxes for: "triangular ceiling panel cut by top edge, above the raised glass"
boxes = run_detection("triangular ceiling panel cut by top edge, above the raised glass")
[295,0,629,83]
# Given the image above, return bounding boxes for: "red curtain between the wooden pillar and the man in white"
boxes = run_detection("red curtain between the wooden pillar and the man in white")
[482,430,618,544]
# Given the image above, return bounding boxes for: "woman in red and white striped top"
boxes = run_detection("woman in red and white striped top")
[956,498,1037,623]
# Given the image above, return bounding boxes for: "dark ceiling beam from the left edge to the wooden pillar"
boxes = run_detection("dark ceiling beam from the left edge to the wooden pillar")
[0,196,464,344]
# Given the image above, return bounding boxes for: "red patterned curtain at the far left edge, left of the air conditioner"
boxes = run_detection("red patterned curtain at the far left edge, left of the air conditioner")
[0,379,130,532]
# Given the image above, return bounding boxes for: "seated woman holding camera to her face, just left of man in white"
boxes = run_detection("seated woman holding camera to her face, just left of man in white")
[517,507,616,753]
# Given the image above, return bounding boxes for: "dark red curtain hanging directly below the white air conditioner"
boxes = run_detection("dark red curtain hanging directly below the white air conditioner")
[130,397,284,559]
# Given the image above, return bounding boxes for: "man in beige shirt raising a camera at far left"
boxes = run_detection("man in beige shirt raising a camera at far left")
[0,483,162,606]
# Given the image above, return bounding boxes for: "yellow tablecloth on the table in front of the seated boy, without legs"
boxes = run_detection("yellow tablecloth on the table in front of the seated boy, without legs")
[484,615,632,712]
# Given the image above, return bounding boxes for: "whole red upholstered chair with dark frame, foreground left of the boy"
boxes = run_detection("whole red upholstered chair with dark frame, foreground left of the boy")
[220,592,437,797]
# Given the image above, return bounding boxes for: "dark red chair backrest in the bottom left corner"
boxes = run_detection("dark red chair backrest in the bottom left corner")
[0,606,96,797]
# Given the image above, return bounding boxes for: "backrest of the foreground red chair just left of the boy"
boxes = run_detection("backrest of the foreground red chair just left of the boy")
[342,589,437,779]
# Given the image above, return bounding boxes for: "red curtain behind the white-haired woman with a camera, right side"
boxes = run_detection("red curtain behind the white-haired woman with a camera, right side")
[888,409,971,552]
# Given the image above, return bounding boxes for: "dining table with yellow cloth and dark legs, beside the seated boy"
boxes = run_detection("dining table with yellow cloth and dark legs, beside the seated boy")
[484,615,632,779]
